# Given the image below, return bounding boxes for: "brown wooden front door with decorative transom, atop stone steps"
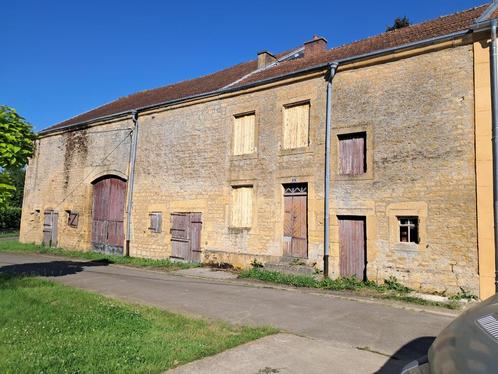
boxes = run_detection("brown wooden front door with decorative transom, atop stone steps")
[283,183,308,258]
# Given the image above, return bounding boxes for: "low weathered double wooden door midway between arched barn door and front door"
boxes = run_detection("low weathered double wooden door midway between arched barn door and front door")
[170,212,202,262]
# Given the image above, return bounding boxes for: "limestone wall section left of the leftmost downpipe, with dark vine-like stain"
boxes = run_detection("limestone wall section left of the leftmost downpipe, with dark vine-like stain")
[20,120,132,250]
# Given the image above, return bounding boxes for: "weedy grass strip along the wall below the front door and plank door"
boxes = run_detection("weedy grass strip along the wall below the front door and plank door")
[239,268,460,309]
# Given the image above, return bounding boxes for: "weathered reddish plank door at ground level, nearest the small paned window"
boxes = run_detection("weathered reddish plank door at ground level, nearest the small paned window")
[339,217,366,280]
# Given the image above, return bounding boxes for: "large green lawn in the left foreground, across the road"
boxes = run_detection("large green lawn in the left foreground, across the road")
[0,274,277,374]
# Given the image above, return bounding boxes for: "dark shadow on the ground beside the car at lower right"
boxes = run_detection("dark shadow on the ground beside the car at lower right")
[377,336,436,374]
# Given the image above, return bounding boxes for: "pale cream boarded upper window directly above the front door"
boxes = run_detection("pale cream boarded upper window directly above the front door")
[283,103,310,149]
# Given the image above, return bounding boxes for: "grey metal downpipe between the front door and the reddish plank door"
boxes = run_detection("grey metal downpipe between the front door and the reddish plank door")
[323,63,338,278]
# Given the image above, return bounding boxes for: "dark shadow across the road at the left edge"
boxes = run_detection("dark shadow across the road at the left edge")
[0,260,110,277]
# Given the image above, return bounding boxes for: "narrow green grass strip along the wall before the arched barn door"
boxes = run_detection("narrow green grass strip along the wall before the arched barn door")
[0,240,199,270]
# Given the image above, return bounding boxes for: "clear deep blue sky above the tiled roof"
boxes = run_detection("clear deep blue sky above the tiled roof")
[0,0,485,130]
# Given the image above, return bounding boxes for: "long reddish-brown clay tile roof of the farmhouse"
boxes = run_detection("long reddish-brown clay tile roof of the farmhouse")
[43,4,489,131]
